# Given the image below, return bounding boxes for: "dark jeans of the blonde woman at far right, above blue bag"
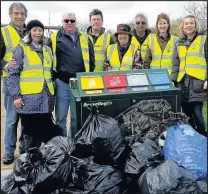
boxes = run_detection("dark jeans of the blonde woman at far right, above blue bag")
[181,102,207,136]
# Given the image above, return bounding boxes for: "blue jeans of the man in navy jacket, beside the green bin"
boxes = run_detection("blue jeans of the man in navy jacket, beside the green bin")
[55,79,71,136]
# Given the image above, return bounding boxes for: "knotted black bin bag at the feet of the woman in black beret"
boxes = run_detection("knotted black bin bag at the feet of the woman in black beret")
[14,137,71,194]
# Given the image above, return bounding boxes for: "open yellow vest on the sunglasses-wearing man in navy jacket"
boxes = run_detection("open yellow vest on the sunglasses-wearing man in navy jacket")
[51,32,90,72]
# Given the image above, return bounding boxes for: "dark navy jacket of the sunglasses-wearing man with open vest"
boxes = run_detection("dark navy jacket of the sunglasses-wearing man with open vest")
[48,28,95,83]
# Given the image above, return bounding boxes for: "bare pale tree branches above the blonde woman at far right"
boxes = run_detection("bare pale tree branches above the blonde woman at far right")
[184,1,207,32]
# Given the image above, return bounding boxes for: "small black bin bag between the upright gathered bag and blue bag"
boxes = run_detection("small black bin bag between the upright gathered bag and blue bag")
[124,136,163,193]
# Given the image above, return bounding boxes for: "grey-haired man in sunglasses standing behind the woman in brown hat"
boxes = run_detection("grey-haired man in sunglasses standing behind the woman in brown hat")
[132,13,151,63]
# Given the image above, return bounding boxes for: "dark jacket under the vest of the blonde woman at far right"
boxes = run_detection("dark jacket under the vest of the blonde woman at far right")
[171,34,208,102]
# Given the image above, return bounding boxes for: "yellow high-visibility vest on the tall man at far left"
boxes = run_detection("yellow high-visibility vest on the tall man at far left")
[1,25,21,77]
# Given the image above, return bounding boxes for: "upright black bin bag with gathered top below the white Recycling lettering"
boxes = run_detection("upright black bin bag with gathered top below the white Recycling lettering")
[71,111,127,168]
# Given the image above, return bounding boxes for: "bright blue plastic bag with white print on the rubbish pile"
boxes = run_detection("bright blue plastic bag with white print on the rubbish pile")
[163,124,207,180]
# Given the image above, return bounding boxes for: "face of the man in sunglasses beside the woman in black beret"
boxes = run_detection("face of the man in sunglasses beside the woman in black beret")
[62,15,76,34]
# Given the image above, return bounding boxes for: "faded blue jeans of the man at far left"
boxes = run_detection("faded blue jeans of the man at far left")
[4,91,23,154]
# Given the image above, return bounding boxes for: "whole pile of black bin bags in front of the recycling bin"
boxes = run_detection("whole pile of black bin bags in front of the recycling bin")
[1,100,207,194]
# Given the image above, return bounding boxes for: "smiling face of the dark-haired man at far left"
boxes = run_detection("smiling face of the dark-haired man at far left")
[10,8,26,27]
